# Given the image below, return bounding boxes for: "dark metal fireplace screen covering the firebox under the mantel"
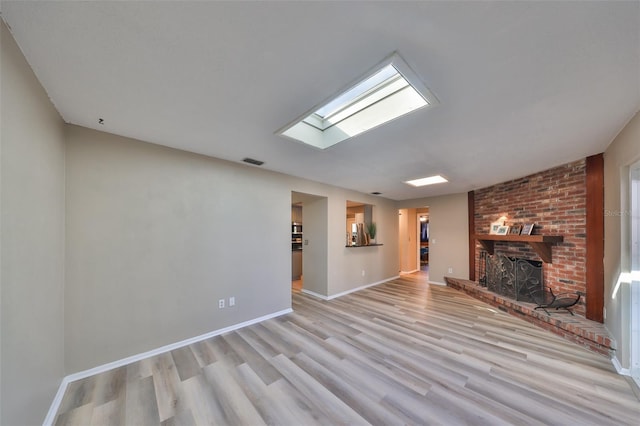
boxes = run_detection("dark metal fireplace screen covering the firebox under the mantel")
[485,255,544,302]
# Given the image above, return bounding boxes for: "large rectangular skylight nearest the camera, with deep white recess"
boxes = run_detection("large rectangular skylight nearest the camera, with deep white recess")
[278,53,438,149]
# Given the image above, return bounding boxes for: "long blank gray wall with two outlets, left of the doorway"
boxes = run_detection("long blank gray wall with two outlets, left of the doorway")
[65,126,291,372]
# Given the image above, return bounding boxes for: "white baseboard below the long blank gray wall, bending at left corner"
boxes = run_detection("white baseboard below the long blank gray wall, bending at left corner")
[43,308,293,426]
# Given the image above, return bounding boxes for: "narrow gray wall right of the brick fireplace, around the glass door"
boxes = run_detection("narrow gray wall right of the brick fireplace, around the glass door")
[604,110,640,368]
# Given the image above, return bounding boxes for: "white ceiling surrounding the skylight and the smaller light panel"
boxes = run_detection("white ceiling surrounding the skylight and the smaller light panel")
[1,1,640,200]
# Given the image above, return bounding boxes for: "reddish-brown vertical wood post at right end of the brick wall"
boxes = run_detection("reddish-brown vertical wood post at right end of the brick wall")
[585,154,604,322]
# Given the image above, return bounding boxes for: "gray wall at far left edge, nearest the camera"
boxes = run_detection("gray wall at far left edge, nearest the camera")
[0,23,65,425]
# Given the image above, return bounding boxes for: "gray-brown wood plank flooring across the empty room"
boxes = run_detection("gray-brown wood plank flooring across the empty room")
[56,274,640,426]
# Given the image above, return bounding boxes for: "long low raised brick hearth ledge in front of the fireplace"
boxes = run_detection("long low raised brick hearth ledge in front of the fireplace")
[445,277,615,358]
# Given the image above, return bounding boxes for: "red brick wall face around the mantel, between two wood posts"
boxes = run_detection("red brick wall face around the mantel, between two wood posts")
[474,160,587,315]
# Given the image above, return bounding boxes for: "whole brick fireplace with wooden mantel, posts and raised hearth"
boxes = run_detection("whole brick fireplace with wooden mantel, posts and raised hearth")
[445,154,616,356]
